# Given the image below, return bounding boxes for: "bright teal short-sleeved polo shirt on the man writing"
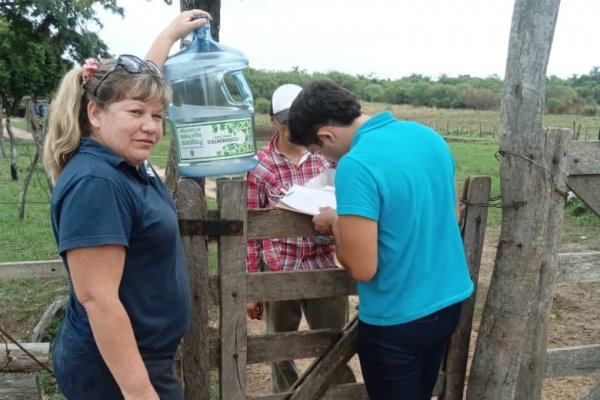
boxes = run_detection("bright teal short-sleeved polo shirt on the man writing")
[335,112,473,326]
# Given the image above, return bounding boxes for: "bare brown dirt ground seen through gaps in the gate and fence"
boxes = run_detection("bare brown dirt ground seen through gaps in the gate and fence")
[247,230,600,400]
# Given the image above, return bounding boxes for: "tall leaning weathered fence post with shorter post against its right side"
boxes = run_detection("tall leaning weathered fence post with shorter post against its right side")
[467,0,569,400]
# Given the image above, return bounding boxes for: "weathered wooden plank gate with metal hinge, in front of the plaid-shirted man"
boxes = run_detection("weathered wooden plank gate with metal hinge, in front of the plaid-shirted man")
[177,177,491,400]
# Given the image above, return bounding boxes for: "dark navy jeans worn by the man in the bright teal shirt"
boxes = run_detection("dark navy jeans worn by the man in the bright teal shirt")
[357,303,461,400]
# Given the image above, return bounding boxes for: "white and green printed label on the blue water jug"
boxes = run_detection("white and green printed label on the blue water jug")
[175,118,254,163]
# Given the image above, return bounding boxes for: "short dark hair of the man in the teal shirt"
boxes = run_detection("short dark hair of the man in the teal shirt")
[288,80,361,146]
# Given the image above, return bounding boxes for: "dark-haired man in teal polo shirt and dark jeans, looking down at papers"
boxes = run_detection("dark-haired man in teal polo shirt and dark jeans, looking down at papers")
[289,81,473,400]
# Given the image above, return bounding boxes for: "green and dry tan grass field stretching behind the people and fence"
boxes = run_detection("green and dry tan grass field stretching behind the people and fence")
[0,103,600,262]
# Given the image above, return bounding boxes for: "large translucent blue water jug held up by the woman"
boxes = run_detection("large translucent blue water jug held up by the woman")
[164,22,258,178]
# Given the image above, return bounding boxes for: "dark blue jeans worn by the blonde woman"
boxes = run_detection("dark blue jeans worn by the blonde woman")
[52,323,183,400]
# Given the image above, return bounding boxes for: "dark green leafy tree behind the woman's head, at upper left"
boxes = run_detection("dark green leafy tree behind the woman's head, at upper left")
[0,0,123,115]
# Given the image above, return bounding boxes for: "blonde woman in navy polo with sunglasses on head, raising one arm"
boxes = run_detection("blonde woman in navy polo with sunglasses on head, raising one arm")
[44,10,206,400]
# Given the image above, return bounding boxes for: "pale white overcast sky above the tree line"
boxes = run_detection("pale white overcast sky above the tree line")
[89,0,600,79]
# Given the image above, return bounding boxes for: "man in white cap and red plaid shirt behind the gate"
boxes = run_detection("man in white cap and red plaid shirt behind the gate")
[246,84,356,393]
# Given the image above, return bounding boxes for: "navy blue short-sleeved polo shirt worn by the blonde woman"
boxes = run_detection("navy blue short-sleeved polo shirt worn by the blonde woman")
[52,138,190,354]
